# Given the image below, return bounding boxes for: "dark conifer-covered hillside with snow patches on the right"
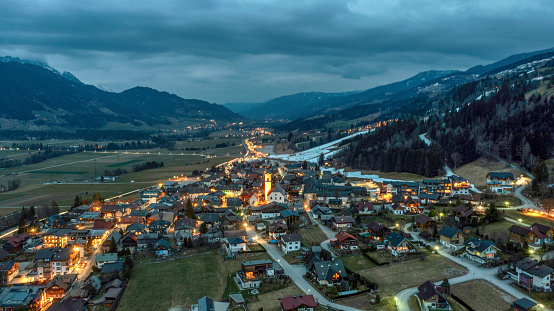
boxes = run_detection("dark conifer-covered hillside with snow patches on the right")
[342,61,554,176]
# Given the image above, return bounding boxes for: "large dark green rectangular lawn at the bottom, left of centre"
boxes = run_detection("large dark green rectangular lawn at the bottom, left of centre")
[117,251,227,311]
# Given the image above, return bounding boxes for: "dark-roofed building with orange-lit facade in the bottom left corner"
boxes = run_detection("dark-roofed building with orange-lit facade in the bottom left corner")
[0,286,48,311]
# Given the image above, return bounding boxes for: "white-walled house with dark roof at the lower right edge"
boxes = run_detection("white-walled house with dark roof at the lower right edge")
[512,258,554,292]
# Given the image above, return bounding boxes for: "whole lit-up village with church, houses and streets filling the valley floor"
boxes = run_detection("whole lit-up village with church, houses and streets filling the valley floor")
[0,141,554,311]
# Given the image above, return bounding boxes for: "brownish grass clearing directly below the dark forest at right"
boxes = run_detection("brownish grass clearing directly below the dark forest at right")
[453,158,522,190]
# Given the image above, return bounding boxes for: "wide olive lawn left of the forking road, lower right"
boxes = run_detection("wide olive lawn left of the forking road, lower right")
[359,255,467,297]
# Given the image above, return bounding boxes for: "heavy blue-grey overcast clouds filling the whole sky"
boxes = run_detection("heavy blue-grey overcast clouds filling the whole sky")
[0,0,554,103]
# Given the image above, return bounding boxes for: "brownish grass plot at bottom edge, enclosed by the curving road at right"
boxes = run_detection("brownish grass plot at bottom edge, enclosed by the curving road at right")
[451,280,516,310]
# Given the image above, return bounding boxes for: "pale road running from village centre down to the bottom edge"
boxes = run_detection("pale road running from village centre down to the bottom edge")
[246,225,359,311]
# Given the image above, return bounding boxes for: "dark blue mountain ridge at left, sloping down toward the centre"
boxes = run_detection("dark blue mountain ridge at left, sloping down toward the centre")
[0,57,244,130]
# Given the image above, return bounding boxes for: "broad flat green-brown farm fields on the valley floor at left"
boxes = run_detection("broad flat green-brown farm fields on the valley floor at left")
[0,139,244,207]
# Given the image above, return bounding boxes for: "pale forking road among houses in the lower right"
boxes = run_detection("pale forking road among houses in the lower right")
[396,225,551,311]
